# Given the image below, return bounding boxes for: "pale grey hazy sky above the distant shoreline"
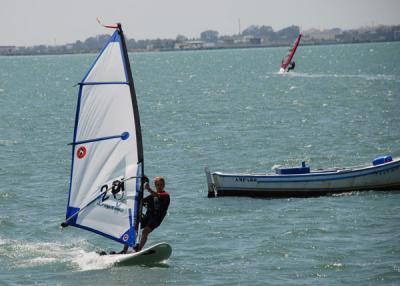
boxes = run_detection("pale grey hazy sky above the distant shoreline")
[0,0,400,46]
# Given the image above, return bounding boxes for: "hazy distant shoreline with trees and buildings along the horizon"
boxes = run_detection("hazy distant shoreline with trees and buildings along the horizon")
[0,25,400,56]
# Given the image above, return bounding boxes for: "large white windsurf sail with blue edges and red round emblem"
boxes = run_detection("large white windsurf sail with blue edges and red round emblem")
[65,24,144,246]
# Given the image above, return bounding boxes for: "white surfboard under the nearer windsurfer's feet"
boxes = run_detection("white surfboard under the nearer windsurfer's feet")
[105,242,172,266]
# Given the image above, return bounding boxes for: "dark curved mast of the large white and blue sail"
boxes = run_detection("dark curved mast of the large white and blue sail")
[117,23,144,236]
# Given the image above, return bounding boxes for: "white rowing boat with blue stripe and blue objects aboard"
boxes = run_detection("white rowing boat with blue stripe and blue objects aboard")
[205,156,400,197]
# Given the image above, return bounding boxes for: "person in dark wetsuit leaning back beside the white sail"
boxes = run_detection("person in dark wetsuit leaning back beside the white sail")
[119,177,170,254]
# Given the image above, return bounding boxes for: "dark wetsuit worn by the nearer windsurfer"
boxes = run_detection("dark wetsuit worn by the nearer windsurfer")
[141,192,170,231]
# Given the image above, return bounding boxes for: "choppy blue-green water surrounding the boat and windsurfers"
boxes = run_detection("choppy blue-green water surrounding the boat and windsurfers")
[0,43,400,285]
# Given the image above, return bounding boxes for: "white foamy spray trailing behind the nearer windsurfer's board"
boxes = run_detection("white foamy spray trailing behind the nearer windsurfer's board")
[0,239,117,271]
